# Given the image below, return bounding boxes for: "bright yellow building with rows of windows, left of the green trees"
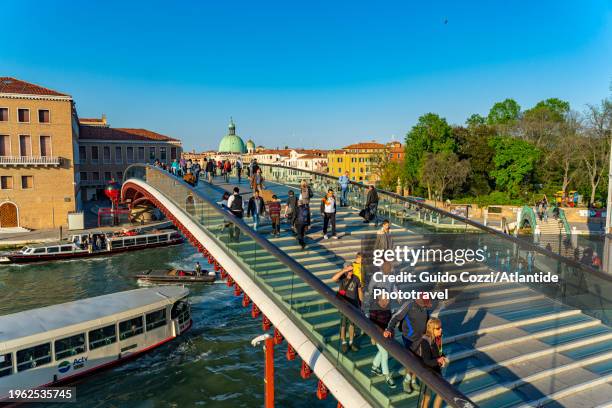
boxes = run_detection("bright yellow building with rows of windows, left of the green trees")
[327,142,386,183]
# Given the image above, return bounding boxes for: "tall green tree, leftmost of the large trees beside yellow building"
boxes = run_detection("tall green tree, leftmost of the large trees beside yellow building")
[404,113,457,187]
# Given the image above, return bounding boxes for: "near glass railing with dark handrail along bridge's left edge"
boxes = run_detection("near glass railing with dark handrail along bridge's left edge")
[125,165,475,407]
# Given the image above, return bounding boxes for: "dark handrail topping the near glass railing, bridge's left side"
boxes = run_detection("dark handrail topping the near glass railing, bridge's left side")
[124,164,477,408]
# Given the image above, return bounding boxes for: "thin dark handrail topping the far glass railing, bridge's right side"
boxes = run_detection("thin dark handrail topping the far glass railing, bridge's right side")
[257,163,612,283]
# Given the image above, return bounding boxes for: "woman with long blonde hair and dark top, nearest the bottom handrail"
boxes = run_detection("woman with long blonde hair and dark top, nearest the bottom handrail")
[413,317,448,408]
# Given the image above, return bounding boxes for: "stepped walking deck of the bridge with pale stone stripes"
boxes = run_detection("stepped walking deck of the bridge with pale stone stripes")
[192,179,612,408]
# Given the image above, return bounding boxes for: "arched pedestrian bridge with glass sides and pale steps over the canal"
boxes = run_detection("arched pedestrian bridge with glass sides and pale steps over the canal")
[122,165,612,407]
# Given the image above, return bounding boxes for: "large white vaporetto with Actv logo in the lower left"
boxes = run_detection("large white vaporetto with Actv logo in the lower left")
[0,286,191,401]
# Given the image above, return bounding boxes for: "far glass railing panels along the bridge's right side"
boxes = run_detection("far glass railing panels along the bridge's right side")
[260,164,612,326]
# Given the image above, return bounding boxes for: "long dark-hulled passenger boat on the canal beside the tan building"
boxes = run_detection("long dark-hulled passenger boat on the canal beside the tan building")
[0,229,184,263]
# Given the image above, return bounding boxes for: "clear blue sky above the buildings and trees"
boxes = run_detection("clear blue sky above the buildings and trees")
[0,0,612,150]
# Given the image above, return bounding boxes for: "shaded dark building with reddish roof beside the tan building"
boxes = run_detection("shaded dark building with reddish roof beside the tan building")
[76,117,182,201]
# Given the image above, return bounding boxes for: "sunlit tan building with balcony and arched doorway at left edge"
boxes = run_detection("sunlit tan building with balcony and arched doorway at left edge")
[0,77,80,229]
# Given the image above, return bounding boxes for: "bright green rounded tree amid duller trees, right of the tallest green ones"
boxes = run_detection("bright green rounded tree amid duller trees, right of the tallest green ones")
[489,136,541,197]
